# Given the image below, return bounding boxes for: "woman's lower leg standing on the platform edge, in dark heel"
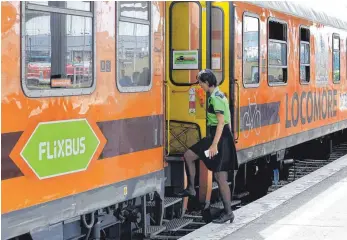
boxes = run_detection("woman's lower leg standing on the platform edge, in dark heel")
[213,171,234,223]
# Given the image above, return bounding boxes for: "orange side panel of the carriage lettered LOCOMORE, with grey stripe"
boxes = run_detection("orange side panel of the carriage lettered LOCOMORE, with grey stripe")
[235,2,347,163]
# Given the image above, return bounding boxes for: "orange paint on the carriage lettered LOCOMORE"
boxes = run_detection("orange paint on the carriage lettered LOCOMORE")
[234,2,347,149]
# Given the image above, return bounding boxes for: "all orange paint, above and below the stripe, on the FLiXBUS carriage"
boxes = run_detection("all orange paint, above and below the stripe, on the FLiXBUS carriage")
[1,1,164,213]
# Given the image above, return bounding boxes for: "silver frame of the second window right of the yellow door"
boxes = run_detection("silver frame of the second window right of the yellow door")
[266,17,289,87]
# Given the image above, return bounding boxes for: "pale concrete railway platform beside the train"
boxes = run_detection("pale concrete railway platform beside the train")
[180,155,347,240]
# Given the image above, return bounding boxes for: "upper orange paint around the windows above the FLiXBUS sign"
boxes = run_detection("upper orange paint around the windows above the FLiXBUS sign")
[1,2,164,133]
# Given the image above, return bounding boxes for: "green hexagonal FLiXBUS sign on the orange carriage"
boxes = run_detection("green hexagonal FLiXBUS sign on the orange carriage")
[21,119,100,179]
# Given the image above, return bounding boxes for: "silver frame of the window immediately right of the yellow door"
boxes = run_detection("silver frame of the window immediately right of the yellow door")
[241,11,262,88]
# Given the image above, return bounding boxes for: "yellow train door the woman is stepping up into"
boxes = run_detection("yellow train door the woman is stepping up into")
[166,1,232,210]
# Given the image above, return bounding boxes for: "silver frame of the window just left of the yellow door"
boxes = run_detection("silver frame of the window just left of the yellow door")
[115,1,154,93]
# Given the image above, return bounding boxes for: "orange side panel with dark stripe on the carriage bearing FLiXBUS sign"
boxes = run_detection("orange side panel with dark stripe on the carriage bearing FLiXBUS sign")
[2,2,164,223]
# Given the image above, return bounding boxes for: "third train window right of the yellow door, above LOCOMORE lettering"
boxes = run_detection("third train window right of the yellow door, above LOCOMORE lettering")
[300,27,310,83]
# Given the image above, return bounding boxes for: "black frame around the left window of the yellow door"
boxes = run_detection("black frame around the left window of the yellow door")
[168,1,203,86]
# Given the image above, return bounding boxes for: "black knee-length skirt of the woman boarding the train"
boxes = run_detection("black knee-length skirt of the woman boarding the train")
[190,124,238,174]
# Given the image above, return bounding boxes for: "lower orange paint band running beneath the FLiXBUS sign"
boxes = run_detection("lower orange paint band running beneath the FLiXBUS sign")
[1,148,163,214]
